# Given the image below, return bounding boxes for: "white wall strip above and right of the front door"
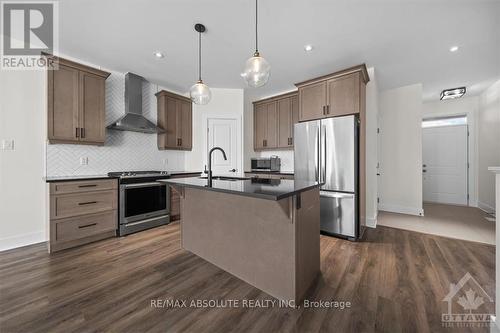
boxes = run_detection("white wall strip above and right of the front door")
[422,96,479,207]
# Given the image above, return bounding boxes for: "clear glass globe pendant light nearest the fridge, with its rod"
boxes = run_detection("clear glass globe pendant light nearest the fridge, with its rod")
[241,0,271,88]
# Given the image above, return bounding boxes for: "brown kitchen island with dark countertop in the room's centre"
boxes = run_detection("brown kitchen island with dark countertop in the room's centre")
[160,178,320,306]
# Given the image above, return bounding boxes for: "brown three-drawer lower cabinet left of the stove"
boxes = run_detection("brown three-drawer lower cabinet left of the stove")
[48,179,118,252]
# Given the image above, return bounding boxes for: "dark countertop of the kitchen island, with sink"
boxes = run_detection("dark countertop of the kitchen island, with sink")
[158,178,320,200]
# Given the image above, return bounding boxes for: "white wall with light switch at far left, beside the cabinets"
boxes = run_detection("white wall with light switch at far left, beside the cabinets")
[0,70,47,251]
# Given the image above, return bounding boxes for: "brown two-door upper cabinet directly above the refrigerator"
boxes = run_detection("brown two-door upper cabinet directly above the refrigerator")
[296,64,369,121]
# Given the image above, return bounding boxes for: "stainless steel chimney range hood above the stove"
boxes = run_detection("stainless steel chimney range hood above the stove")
[106,73,165,133]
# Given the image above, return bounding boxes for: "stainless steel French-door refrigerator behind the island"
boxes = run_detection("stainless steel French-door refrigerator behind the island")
[294,115,361,240]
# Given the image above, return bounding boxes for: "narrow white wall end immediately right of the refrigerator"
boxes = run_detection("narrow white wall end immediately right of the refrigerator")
[366,67,379,227]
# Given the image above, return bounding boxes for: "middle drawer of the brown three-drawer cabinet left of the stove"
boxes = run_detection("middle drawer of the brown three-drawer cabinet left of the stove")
[50,190,117,219]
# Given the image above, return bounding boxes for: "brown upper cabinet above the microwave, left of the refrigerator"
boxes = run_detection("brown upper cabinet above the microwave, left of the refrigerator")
[254,92,299,150]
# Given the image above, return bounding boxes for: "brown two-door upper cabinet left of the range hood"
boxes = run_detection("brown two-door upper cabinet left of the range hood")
[45,55,110,145]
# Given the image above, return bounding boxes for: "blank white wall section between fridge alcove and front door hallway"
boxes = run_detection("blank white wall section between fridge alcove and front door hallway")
[378,84,423,215]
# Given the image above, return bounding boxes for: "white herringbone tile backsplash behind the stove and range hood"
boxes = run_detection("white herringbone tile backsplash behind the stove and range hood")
[46,72,191,177]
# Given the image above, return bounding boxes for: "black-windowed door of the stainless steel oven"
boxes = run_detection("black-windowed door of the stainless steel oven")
[120,182,169,224]
